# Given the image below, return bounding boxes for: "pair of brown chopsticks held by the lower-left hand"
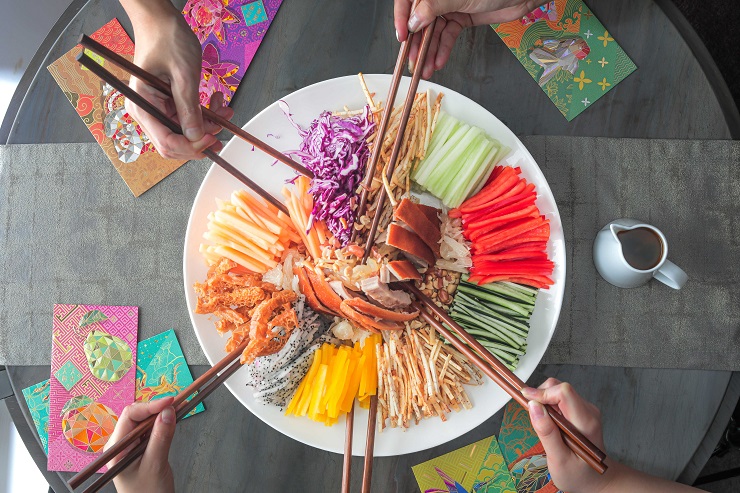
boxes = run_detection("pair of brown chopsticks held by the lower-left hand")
[67,341,249,493]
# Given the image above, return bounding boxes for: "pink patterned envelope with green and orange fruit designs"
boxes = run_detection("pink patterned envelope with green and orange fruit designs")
[48,305,139,472]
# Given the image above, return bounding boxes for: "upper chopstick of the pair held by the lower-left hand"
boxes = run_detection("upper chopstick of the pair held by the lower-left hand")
[67,341,249,490]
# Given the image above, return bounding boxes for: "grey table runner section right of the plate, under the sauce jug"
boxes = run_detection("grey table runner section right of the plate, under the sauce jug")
[522,136,740,370]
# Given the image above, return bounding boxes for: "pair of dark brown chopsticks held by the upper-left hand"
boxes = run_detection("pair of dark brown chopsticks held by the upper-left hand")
[72,34,314,215]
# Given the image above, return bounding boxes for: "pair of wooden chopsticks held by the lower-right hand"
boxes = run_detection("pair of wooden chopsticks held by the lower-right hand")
[401,282,607,474]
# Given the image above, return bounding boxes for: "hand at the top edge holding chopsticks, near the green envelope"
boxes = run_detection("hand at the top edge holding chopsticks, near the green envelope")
[394,0,546,79]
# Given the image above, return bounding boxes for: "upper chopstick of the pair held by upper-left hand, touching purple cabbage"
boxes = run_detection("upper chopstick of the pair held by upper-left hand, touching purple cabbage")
[78,34,314,178]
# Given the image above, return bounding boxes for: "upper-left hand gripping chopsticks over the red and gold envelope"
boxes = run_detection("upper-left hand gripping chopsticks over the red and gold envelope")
[121,0,234,159]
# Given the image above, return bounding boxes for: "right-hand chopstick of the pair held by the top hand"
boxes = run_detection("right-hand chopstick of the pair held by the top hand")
[362,18,437,263]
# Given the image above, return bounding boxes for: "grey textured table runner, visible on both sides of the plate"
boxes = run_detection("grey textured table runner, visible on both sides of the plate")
[0,137,740,370]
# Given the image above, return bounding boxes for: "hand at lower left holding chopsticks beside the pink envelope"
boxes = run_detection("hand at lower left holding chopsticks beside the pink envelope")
[105,397,176,493]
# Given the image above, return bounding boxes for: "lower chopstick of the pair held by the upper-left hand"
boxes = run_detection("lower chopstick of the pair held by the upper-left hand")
[77,51,289,215]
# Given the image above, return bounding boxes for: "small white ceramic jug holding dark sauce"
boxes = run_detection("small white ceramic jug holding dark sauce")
[594,219,689,289]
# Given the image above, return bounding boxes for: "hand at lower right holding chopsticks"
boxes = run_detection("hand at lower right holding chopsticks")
[522,378,611,493]
